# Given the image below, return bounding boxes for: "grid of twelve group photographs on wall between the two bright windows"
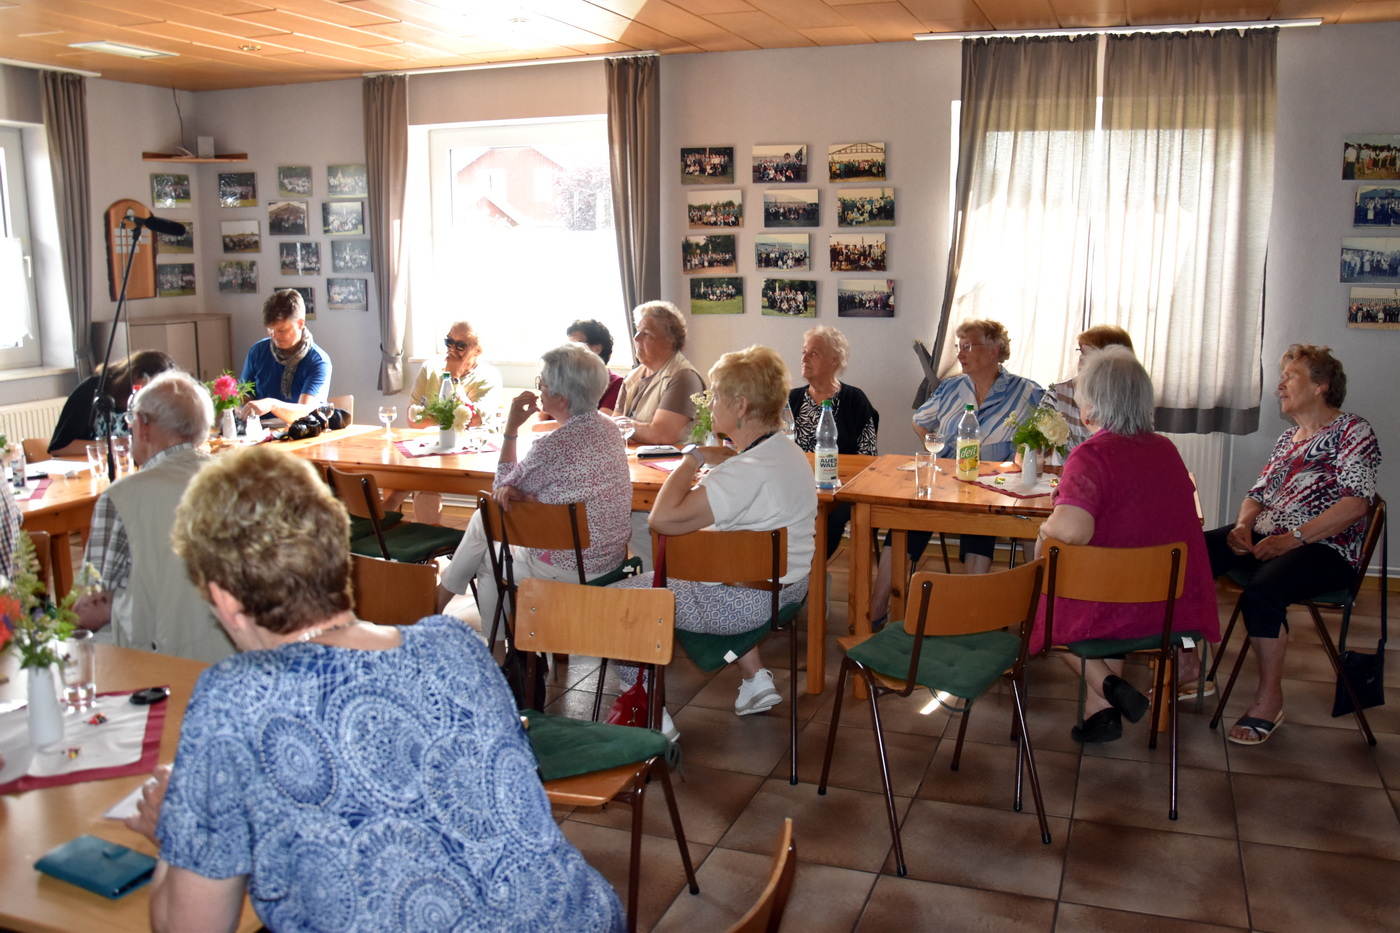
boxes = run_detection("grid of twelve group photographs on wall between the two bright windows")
[679,141,896,318]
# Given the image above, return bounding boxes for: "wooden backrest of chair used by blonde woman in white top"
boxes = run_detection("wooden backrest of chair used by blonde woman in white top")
[651,528,787,590]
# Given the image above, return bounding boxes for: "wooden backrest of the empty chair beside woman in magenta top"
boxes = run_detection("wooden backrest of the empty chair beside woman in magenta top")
[904,558,1046,635]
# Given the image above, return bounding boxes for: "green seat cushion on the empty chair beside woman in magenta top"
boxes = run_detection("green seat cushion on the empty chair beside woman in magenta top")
[847,622,1021,700]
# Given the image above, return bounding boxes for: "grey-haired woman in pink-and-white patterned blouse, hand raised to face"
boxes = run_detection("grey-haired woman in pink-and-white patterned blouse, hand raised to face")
[438,343,631,622]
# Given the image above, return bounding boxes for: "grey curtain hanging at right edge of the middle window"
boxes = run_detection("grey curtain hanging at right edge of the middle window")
[606,55,661,363]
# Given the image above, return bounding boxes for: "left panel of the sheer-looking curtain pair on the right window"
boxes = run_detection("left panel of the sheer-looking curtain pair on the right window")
[930,36,1098,389]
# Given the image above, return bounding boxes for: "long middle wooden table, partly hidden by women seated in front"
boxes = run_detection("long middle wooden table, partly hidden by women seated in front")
[295,426,876,693]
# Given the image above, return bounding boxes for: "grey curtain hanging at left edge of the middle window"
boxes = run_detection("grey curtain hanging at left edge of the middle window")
[364,74,409,395]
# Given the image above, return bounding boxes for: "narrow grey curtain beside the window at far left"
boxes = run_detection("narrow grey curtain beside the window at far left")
[42,71,92,378]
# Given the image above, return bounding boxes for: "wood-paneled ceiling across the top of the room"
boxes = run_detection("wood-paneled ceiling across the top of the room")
[0,0,1400,91]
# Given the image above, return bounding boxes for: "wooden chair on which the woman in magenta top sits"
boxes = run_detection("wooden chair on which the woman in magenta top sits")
[1040,538,1201,820]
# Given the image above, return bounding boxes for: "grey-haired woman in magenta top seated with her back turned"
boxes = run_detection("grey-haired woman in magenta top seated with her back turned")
[1030,346,1221,744]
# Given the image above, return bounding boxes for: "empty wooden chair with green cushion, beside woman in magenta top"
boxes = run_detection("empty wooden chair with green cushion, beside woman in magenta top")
[816,560,1050,877]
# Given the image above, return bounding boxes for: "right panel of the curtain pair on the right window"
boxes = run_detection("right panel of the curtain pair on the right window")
[1091,29,1278,434]
